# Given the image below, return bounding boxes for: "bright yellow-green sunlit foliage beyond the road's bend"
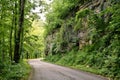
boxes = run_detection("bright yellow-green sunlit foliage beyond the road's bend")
[22,20,44,58]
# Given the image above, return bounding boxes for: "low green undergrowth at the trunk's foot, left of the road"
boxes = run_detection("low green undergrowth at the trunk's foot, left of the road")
[0,61,30,80]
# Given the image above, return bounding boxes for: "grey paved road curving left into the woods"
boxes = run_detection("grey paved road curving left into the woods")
[29,59,108,80]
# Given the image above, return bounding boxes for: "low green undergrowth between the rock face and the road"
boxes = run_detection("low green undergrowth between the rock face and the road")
[45,47,120,80]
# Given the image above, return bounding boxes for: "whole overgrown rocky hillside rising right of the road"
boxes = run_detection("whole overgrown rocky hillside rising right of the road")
[45,0,120,80]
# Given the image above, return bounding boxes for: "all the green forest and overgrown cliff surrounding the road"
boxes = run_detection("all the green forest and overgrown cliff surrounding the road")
[0,0,120,80]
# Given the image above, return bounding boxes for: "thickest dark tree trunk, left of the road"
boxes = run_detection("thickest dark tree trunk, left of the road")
[14,0,25,63]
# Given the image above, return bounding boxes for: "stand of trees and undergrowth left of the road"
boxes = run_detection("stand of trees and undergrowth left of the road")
[0,0,44,80]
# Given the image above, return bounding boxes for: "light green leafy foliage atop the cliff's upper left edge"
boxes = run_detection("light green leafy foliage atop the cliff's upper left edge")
[45,0,83,35]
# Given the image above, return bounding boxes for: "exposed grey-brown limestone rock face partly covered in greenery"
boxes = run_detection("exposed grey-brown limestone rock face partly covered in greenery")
[45,0,110,55]
